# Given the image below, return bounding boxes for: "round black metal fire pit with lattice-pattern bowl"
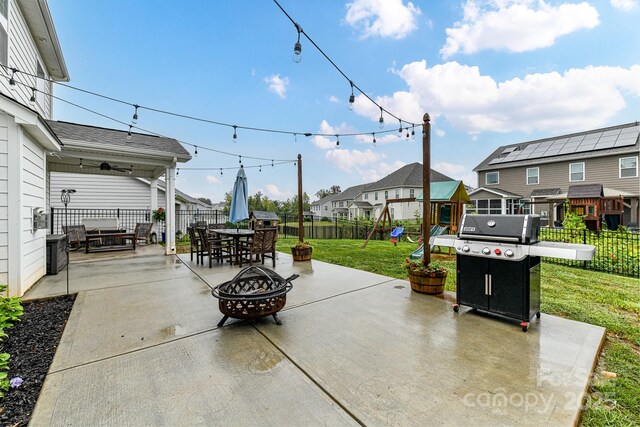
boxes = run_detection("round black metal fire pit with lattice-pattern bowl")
[211,267,298,326]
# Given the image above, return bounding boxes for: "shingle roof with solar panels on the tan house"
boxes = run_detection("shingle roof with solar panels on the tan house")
[473,122,640,172]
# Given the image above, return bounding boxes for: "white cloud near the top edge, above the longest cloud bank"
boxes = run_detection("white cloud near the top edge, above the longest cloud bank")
[440,0,600,58]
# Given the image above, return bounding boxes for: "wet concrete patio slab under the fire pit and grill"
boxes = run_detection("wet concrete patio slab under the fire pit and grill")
[25,249,604,426]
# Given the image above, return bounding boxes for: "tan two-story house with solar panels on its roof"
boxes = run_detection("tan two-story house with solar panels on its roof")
[469,122,640,224]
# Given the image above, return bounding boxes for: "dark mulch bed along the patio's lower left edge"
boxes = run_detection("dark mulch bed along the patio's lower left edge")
[0,295,76,426]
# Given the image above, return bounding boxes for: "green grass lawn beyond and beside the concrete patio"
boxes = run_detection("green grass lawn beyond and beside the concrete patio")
[278,238,640,426]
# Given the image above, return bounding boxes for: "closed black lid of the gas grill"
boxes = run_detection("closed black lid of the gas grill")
[458,214,540,244]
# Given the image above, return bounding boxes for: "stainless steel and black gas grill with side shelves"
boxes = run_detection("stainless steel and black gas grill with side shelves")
[430,215,596,332]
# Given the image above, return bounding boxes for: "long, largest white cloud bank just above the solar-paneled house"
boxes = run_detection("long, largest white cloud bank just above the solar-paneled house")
[388,60,640,134]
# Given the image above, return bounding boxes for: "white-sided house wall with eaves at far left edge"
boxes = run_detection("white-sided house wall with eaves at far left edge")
[0,0,69,295]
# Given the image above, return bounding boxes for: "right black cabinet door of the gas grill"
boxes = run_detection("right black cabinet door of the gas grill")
[489,259,529,321]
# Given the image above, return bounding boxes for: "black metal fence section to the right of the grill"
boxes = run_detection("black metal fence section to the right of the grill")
[540,228,640,277]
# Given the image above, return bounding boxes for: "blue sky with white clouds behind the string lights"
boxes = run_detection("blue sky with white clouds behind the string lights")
[49,0,640,202]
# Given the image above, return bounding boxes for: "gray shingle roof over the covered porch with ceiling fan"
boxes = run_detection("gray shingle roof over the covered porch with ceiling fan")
[47,120,191,160]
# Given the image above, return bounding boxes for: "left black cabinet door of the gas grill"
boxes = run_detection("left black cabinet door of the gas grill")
[456,255,489,310]
